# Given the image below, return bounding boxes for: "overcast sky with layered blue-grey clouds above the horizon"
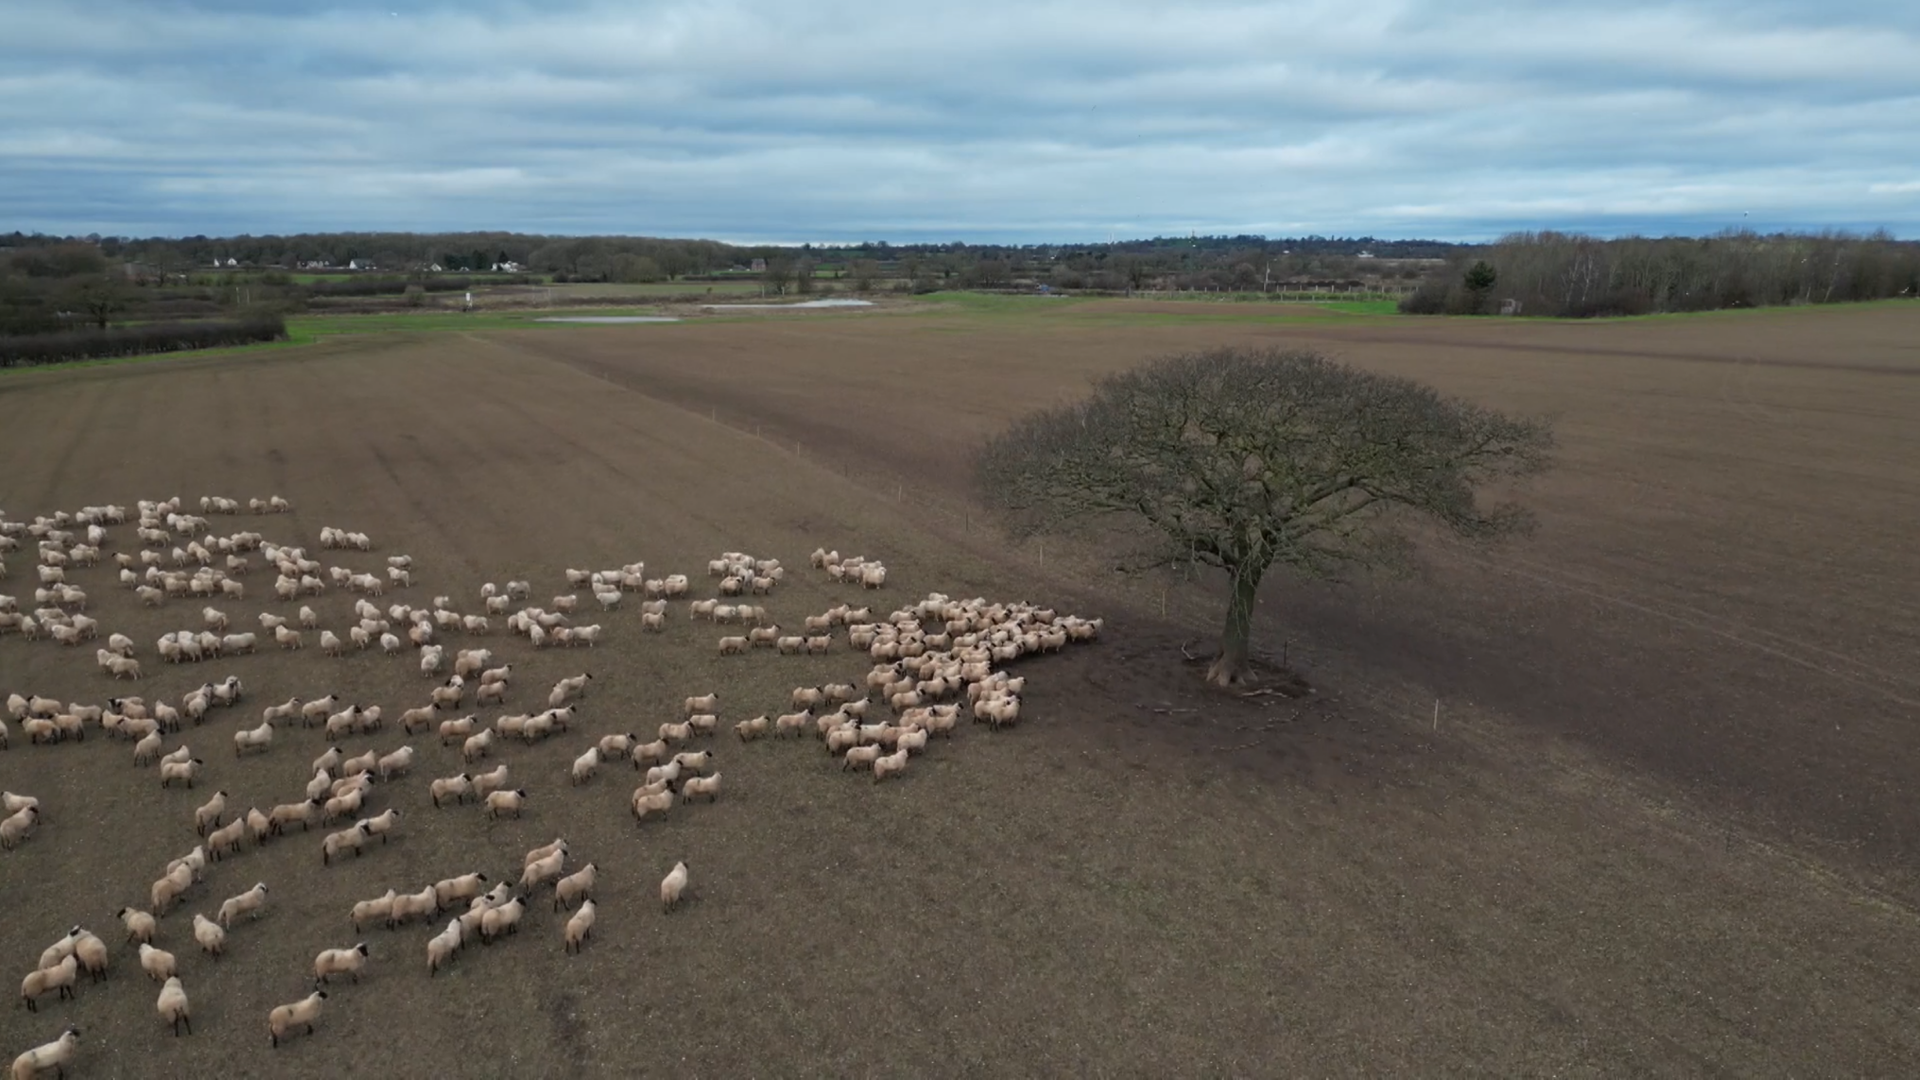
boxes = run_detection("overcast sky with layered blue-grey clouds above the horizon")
[0,0,1920,242]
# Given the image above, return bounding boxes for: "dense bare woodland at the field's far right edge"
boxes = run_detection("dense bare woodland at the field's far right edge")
[1400,233,1920,319]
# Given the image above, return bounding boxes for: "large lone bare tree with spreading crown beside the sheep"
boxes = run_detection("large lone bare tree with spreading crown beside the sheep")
[975,350,1553,686]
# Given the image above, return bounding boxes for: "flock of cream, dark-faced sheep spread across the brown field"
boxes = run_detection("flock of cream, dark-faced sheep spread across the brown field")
[0,496,1100,1080]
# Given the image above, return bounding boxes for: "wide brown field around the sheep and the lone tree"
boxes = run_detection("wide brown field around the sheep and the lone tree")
[0,302,1920,1078]
